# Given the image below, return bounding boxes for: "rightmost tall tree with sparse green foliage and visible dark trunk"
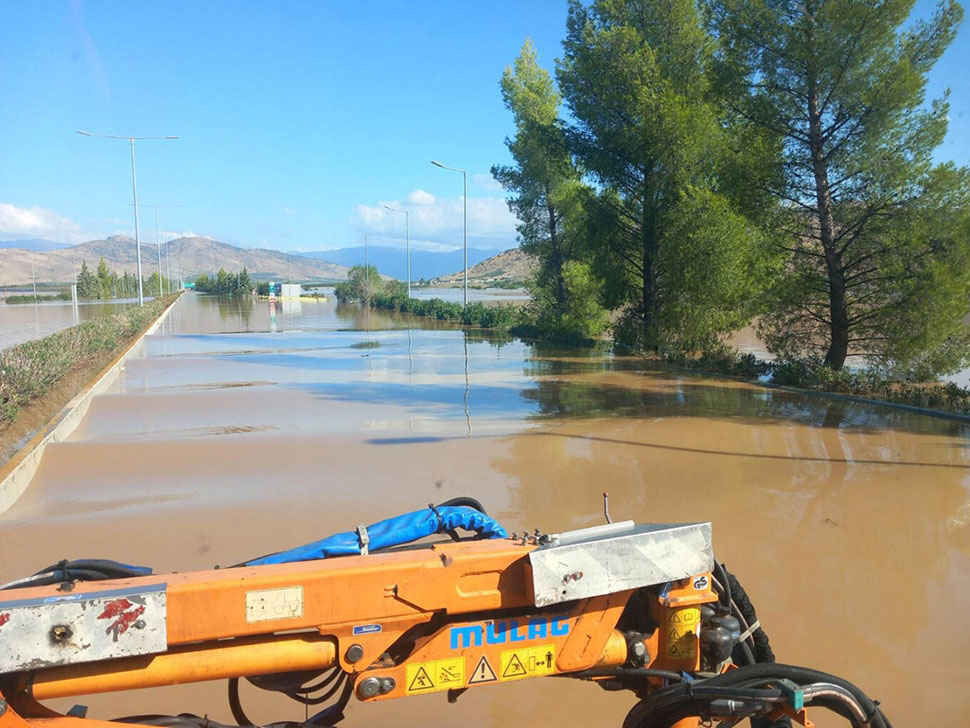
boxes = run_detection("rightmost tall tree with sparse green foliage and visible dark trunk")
[707,0,970,376]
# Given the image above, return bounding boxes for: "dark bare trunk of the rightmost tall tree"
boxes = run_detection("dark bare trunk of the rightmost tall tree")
[808,74,849,371]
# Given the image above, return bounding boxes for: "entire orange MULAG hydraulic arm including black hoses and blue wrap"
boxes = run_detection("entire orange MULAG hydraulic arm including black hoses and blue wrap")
[0,506,888,728]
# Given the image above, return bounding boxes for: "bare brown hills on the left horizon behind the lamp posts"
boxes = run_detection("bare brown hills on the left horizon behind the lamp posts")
[0,236,347,285]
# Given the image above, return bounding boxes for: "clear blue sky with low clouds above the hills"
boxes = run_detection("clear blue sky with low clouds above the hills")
[0,0,970,250]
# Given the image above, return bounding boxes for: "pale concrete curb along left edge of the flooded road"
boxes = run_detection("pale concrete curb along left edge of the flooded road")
[0,294,181,513]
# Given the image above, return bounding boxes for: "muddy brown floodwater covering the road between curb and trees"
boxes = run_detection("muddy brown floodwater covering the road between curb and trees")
[0,294,970,727]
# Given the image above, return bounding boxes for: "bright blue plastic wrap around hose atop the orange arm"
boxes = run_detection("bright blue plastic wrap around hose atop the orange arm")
[245,506,508,566]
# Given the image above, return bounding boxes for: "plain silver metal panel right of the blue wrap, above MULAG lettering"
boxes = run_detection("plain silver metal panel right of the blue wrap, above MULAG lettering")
[529,522,714,607]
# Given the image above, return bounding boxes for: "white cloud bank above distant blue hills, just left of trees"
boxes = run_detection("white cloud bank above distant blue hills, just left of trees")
[351,190,516,250]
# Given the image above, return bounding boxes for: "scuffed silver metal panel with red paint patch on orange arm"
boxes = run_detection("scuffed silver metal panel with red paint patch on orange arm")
[0,584,168,674]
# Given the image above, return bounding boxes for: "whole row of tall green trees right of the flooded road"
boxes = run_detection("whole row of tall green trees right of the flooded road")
[492,0,970,376]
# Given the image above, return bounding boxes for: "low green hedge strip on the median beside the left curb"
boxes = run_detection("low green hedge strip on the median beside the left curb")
[0,296,174,430]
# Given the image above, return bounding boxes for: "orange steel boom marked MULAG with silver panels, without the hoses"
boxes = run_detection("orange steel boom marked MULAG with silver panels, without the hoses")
[0,523,856,728]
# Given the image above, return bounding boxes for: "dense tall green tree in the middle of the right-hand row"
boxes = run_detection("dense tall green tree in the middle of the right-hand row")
[557,0,771,350]
